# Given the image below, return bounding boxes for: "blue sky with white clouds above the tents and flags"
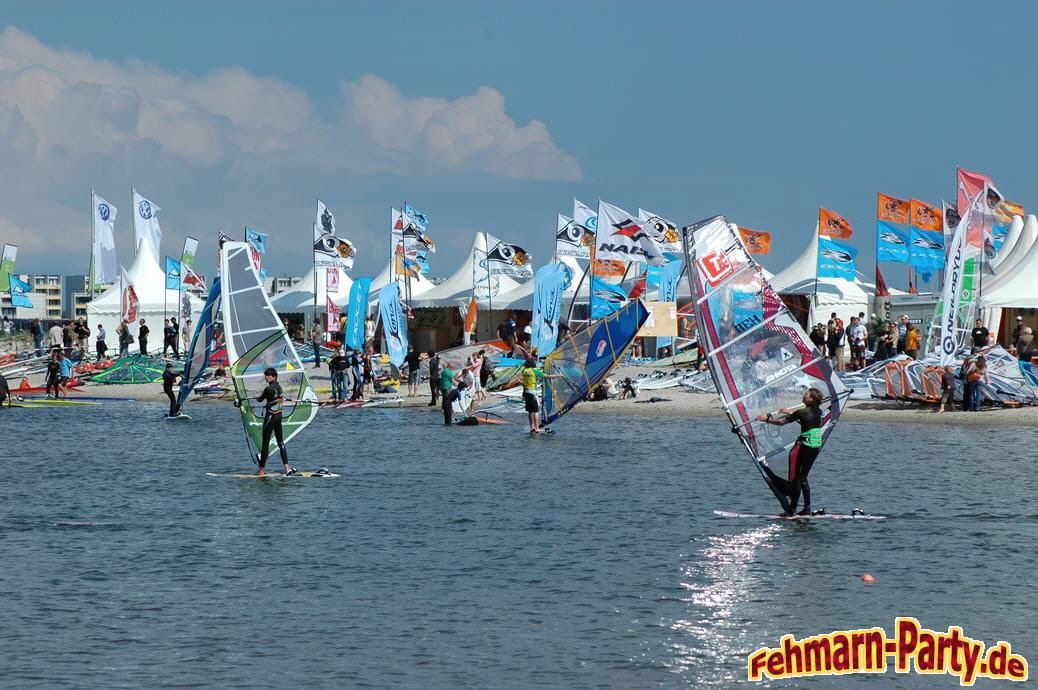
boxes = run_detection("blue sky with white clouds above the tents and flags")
[0,2,1038,282]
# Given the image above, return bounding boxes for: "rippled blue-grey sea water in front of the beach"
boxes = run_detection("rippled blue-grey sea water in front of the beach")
[0,403,1038,688]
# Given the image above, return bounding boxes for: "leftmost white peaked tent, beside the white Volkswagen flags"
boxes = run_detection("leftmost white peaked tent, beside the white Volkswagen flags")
[86,239,202,353]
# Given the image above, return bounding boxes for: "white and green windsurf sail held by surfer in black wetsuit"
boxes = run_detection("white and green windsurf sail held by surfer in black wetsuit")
[220,242,318,452]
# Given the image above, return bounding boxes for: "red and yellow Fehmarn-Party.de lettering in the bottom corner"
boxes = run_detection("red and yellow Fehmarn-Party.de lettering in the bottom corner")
[746,617,1028,686]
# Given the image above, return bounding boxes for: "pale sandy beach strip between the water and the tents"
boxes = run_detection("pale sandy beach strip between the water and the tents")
[15,367,1038,426]
